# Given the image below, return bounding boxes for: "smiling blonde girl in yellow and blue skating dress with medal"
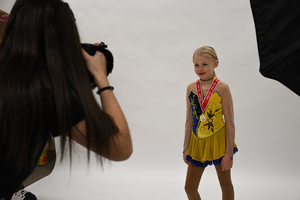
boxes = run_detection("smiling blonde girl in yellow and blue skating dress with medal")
[183,46,238,200]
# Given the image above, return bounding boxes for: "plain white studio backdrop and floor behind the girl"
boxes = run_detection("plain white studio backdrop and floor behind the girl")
[0,0,300,199]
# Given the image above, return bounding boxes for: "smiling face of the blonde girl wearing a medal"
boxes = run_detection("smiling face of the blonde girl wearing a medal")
[194,55,219,80]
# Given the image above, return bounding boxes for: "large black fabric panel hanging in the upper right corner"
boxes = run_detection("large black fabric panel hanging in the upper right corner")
[250,0,300,96]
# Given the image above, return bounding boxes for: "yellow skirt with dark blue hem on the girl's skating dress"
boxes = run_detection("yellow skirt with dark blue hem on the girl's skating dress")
[187,126,238,167]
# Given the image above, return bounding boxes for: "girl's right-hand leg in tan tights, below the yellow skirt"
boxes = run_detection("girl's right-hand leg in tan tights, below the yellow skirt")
[215,165,234,200]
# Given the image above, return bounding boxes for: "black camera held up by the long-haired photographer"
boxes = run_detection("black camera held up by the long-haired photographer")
[81,42,114,87]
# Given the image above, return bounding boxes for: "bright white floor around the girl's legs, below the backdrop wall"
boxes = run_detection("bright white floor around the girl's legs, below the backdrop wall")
[26,147,300,200]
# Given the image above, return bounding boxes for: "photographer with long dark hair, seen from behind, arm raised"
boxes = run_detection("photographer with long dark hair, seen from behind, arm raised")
[0,0,132,200]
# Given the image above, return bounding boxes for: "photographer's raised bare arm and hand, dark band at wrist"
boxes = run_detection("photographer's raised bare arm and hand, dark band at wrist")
[72,49,132,161]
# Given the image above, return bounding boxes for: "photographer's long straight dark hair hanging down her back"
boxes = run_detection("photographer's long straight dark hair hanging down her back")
[0,0,118,170]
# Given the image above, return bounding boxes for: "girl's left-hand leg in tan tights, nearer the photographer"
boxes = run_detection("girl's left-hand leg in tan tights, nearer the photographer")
[185,162,205,200]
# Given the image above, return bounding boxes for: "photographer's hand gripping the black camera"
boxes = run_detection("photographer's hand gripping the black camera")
[82,43,107,77]
